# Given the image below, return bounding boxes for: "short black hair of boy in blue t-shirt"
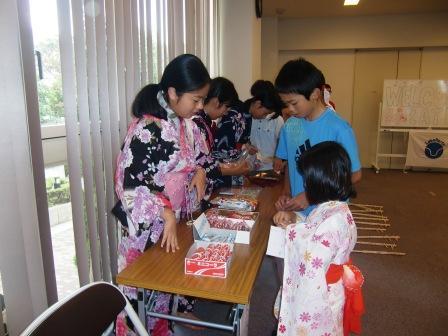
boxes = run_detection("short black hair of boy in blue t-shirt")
[275,58,325,100]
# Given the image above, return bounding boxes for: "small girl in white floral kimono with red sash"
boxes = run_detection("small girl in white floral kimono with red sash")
[274,141,364,336]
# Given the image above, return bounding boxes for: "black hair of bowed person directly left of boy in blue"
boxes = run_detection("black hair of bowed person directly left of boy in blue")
[244,79,284,119]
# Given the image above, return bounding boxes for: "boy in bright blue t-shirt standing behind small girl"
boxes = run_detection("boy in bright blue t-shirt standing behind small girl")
[275,58,361,224]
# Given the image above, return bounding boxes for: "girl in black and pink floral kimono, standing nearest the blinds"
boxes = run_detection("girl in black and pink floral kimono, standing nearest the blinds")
[113,55,214,335]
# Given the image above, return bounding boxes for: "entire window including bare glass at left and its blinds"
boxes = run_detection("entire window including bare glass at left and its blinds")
[30,0,218,297]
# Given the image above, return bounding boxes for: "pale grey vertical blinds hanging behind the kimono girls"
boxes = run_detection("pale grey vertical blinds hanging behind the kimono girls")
[58,0,219,285]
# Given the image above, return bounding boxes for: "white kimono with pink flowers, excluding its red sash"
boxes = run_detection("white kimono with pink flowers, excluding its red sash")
[277,201,356,336]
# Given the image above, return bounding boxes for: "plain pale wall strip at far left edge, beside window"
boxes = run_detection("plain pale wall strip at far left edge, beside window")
[0,0,47,335]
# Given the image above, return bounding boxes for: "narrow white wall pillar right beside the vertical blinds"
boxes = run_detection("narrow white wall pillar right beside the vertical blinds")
[220,0,261,100]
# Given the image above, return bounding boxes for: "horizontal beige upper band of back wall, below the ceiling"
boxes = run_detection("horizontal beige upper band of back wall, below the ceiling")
[278,12,448,50]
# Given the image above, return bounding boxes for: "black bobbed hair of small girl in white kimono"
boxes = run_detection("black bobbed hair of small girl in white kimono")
[297,141,356,204]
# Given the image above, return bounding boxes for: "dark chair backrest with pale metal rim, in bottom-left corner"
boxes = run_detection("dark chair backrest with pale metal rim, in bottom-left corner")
[21,282,127,336]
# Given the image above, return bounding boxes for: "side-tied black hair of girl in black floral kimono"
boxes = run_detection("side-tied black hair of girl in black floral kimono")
[132,54,210,120]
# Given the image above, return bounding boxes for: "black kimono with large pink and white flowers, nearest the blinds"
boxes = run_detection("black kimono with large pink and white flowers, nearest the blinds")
[112,94,216,336]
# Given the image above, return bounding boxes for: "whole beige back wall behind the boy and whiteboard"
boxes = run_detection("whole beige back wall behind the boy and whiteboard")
[262,13,448,168]
